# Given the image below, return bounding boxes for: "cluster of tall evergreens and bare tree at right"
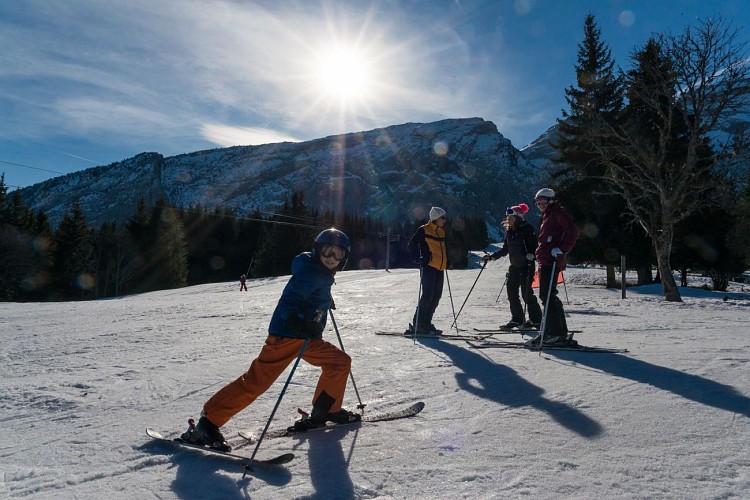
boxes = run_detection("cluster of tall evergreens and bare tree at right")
[552,15,750,301]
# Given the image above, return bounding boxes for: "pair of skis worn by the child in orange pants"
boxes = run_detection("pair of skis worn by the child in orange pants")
[146,402,424,473]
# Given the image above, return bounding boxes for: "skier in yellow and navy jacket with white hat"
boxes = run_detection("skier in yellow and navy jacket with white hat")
[406,207,448,335]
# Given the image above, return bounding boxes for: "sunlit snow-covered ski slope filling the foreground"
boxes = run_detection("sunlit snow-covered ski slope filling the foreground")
[0,260,750,499]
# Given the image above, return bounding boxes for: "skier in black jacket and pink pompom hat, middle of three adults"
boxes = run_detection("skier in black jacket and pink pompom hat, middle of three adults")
[482,203,542,330]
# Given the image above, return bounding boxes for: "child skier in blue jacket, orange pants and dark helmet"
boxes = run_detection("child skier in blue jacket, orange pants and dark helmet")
[193,228,361,451]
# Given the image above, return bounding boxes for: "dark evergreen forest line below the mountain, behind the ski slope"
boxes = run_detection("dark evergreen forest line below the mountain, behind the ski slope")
[0,182,488,301]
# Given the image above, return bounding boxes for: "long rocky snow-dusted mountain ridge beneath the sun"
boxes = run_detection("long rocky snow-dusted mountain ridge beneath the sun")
[21,118,544,226]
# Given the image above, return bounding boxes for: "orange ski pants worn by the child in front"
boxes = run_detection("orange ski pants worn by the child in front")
[203,335,352,427]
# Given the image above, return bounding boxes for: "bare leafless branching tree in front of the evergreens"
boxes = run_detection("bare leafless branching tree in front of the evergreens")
[590,20,750,302]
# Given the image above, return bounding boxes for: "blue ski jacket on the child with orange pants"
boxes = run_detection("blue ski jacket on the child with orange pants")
[268,252,334,338]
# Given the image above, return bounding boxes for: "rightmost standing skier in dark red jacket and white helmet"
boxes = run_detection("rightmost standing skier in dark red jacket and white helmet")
[532,188,578,345]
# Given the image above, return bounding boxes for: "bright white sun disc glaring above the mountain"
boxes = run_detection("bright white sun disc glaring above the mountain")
[317,47,371,101]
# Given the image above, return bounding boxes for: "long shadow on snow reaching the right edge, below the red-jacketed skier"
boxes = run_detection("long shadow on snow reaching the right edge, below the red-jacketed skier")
[547,351,750,417]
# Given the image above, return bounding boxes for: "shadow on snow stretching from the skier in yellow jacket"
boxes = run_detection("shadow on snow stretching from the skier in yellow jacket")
[428,339,602,438]
